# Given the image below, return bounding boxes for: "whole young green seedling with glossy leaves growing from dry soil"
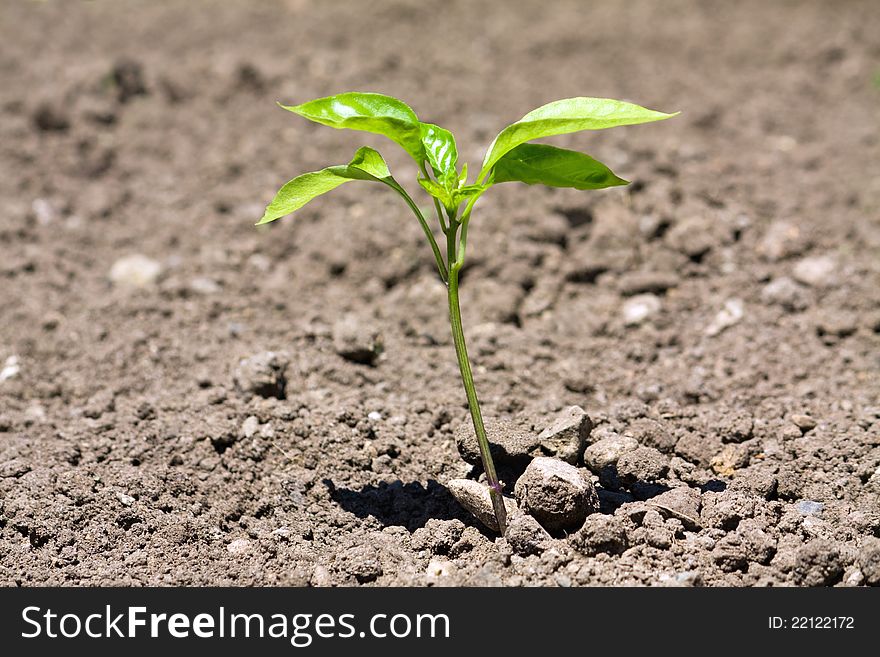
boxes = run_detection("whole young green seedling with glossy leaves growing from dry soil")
[257,93,675,533]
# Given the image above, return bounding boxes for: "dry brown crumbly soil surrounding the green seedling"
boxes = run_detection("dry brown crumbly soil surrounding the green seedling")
[0,0,880,586]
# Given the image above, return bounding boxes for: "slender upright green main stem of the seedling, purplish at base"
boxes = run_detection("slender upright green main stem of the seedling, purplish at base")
[447,230,507,534]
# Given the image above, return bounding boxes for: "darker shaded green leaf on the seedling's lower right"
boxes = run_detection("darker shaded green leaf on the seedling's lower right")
[492,144,627,189]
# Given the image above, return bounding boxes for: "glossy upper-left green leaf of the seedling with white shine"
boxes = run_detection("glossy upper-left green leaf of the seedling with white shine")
[279,92,425,164]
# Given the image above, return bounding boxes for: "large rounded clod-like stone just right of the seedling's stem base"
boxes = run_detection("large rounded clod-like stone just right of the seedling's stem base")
[514,456,599,532]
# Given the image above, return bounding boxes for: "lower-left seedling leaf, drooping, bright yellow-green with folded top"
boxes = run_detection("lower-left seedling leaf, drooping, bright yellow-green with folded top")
[257,146,396,226]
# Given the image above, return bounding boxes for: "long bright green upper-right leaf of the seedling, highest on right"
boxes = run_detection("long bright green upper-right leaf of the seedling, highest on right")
[478,97,677,180]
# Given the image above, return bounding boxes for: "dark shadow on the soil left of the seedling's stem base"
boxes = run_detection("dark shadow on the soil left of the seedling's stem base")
[323,479,473,532]
